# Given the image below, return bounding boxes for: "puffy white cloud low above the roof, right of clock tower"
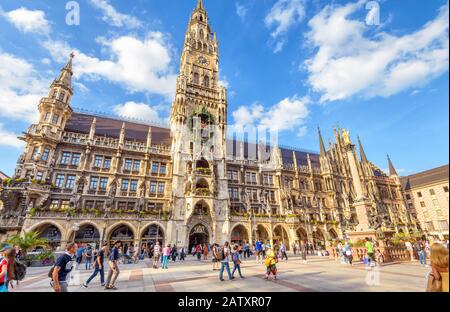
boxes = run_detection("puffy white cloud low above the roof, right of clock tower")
[232,96,310,135]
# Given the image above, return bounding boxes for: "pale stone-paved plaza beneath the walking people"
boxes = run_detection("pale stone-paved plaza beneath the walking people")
[13,256,429,292]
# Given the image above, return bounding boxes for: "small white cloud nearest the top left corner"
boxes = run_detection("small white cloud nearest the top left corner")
[0,7,50,35]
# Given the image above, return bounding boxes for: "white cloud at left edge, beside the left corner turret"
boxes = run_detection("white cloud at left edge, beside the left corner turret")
[0,53,51,122]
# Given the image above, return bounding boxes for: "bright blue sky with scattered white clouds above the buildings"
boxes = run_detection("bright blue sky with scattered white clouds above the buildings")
[0,0,449,175]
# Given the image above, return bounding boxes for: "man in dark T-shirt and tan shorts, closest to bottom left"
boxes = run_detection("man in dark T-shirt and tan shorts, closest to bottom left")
[50,243,77,292]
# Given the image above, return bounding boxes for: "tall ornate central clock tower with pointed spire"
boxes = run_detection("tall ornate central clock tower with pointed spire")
[167,0,230,248]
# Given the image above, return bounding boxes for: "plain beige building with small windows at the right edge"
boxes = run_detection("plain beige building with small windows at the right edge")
[401,165,448,239]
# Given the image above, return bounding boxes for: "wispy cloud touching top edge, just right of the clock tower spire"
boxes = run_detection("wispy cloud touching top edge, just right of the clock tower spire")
[264,0,305,53]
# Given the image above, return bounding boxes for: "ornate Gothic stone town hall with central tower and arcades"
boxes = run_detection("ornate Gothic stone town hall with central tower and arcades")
[0,1,416,249]
